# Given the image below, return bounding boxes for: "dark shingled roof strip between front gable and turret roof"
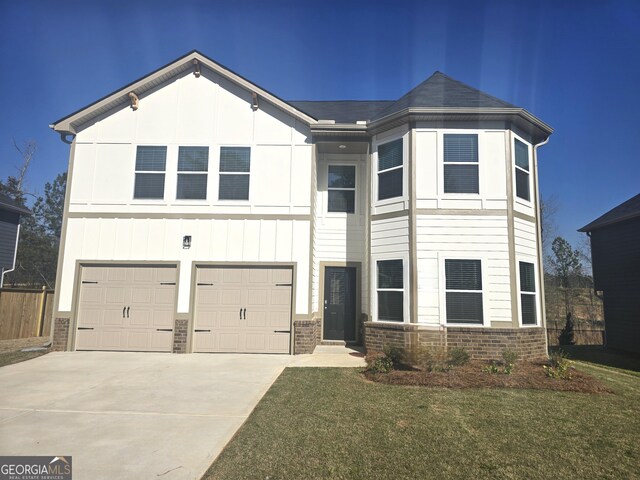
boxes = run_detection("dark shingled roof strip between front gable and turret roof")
[289,100,394,123]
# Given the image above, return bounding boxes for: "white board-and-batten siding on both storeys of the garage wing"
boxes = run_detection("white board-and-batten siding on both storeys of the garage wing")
[58,69,313,315]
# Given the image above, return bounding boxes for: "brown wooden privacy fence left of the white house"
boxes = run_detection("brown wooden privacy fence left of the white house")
[0,288,53,340]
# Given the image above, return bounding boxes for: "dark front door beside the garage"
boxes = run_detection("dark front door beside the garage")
[323,267,356,341]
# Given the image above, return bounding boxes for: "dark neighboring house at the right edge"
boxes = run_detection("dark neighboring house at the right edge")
[579,194,640,353]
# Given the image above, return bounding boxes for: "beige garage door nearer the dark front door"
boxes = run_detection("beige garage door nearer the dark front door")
[194,267,293,353]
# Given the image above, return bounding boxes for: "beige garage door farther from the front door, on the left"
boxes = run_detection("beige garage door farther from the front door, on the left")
[76,266,176,352]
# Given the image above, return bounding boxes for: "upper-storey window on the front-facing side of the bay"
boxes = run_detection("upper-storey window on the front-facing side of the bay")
[444,134,480,193]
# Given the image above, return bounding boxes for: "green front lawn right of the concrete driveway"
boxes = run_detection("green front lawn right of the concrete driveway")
[204,366,640,480]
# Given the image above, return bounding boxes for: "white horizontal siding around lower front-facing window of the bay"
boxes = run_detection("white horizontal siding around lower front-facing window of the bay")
[416,215,512,325]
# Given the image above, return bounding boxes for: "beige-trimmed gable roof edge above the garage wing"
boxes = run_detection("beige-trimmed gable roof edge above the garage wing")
[49,50,315,134]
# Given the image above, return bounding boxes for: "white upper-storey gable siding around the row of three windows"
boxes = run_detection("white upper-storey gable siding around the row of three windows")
[70,71,312,215]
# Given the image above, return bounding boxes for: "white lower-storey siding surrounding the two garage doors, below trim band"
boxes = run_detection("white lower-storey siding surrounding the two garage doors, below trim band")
[59,218,310,314]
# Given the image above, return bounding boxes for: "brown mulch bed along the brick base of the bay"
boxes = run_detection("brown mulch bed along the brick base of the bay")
[364,361,613,393]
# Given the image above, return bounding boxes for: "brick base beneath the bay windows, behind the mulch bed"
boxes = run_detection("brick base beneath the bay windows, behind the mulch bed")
[364,322,547,360]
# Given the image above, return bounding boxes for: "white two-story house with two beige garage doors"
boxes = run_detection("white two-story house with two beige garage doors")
[51,51,552,358]
